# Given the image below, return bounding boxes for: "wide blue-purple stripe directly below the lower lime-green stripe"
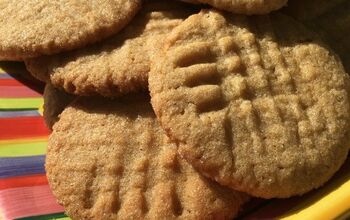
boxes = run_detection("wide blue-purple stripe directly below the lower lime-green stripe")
[0,155,45,178]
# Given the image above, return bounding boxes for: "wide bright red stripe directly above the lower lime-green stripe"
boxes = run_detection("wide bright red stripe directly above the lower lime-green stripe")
[0,116,49,140]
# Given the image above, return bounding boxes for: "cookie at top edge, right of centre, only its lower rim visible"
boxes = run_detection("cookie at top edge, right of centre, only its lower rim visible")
[182,0,288,15]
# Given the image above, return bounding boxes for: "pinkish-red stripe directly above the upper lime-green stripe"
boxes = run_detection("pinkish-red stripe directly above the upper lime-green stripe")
[0,86,41,98]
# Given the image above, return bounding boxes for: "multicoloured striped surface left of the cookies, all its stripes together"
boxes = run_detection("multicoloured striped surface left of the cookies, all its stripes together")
[0,65,67,220]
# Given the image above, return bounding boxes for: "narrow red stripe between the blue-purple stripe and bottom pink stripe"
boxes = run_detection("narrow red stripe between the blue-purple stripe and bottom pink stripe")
[0,175,48,190]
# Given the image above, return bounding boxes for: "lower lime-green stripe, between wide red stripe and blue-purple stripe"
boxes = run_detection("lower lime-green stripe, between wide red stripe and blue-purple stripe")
[0,141,47,157]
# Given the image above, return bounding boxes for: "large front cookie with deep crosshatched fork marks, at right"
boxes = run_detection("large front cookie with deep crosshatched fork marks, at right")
[149,10,350,198]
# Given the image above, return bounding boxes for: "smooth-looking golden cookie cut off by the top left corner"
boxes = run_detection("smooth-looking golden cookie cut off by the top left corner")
[0,0,141,60]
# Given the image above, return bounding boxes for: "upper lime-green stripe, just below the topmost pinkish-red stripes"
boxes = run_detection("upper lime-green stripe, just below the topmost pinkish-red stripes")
[0,98,43,109]
